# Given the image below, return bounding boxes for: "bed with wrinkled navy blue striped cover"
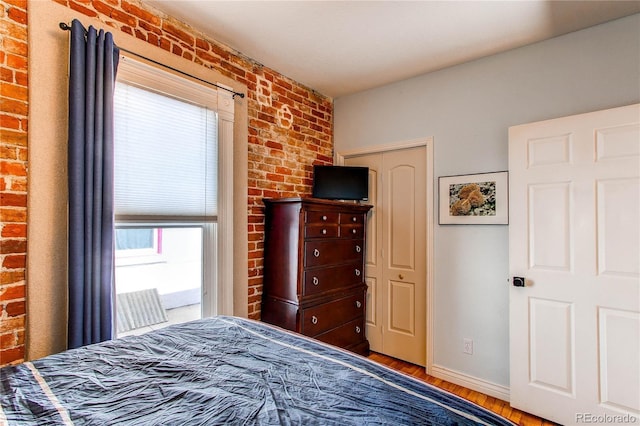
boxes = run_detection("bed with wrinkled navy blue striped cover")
[0,316,513,426]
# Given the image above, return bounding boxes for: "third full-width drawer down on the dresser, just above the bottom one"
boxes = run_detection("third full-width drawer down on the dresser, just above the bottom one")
[301,290,364,337]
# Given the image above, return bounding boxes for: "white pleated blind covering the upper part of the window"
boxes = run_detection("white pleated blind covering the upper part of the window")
[115,82,218,220]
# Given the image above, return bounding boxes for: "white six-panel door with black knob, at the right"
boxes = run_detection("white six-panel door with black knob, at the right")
[509,105,640,425]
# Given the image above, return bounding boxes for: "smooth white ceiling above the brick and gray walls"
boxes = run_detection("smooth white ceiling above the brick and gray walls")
[143,0,640,98]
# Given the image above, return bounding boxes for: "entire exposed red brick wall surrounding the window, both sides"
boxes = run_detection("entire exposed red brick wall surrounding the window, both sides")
[0,0,333,365]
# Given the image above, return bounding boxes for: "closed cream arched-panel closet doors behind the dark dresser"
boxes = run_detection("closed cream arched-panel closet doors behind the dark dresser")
[345,147,427,366]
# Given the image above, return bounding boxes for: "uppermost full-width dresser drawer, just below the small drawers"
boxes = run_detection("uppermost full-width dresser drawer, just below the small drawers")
[304,239,364,267]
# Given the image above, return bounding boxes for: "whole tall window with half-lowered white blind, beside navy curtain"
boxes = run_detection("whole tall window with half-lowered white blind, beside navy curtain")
[115,57,232,335]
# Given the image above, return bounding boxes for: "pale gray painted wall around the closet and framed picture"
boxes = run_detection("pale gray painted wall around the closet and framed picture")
[334,14,640,386]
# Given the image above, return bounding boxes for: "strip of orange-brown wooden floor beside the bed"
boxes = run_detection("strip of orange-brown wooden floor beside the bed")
[369,352,555,426]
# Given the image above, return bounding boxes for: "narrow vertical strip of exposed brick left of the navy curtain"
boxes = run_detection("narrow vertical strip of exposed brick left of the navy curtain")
[0,0,28,365]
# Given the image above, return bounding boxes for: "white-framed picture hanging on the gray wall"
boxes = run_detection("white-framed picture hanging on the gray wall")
[438,172,509,225]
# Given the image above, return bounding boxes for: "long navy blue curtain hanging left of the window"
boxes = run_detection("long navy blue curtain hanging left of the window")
[67,20,119,349]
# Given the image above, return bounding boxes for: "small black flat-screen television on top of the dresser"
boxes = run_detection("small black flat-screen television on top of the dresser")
[312,165,369,201]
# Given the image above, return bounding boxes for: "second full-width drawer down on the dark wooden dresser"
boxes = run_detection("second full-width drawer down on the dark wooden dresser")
[302,261,363,296]
